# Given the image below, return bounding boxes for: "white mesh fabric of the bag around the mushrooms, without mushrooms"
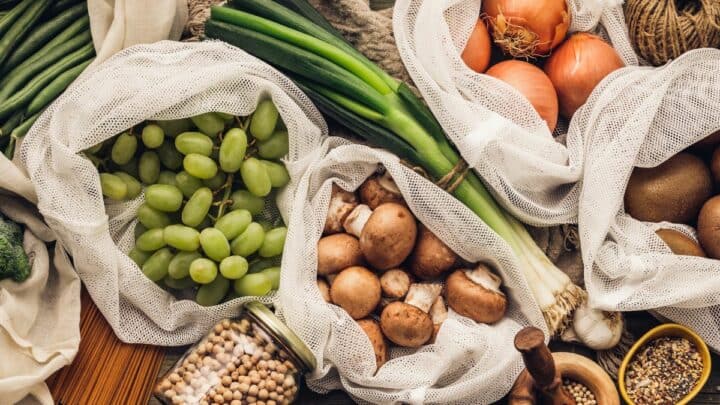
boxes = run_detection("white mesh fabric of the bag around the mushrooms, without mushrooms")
[279,138,547,404]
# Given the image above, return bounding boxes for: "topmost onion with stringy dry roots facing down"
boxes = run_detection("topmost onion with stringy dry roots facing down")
[483,0,570,58]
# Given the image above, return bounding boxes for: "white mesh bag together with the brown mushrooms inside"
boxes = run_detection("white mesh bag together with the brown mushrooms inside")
[279,138,546,404]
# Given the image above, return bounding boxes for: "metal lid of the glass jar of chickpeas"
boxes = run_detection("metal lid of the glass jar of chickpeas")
[245,301,316,372]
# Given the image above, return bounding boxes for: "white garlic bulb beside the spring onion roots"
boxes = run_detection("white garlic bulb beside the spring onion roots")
[561,301,623,350]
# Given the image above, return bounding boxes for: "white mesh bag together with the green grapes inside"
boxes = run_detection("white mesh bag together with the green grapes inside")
[20,41,327,345]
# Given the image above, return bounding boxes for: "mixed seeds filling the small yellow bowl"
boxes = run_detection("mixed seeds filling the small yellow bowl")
[625,337,703,405]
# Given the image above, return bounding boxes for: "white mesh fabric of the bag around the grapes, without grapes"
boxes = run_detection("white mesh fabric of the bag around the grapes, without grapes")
[20,41,327,345]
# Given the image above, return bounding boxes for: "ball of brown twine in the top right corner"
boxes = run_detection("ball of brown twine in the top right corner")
[625,0,720,66]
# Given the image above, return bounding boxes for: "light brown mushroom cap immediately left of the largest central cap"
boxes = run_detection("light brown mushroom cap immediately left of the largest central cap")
[318,233,363,276]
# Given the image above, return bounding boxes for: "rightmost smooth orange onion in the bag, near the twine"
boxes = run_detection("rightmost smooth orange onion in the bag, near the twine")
[545,32,625,119]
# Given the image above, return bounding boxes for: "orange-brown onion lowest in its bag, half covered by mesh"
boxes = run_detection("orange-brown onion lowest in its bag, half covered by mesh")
[485,60,558,132]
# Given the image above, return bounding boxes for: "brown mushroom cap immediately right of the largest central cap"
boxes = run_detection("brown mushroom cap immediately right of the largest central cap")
[410,225,457,280]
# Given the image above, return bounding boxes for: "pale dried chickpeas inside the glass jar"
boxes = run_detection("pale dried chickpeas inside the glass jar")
[155,319,299,405]
